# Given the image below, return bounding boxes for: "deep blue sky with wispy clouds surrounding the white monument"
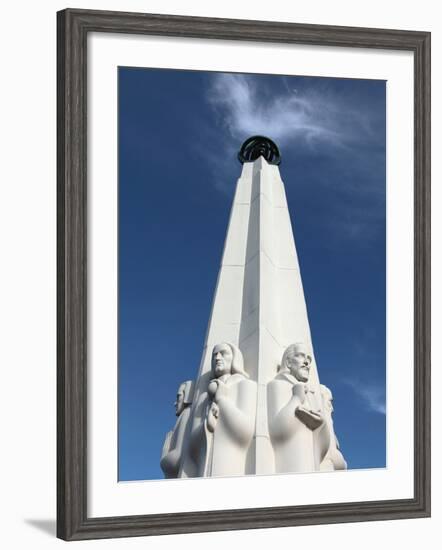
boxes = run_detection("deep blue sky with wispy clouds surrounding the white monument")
[118,67,386,480]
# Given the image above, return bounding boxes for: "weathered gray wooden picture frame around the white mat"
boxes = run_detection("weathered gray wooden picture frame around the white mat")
[57,9,430,540]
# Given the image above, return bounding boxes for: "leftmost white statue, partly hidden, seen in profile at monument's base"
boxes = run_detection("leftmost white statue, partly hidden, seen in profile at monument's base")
[160,380,193,478]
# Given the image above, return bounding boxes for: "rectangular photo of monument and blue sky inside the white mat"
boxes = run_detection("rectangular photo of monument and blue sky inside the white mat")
[117,66,388,482]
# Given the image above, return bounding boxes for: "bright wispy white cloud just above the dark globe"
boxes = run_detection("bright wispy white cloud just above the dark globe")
[208,73,372,152]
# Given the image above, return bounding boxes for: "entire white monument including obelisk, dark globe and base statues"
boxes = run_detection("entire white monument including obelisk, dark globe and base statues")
[161,136,347,477]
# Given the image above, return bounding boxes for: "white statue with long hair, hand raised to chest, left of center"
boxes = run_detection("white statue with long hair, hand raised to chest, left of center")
[187,342,257,477]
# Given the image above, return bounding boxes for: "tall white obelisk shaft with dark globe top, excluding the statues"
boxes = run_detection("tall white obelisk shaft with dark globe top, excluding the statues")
[162,136,346,477]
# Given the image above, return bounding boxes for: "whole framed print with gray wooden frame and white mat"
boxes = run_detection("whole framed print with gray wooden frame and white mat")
[57,9,430,540]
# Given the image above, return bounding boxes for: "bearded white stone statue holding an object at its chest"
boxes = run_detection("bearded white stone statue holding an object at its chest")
[267,343,330,473]
